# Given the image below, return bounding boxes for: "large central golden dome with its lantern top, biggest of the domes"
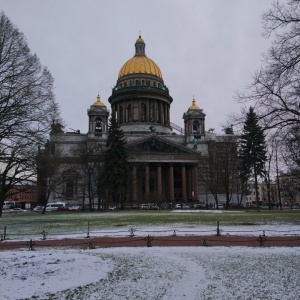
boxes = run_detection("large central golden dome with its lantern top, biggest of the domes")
[118,36,162,79]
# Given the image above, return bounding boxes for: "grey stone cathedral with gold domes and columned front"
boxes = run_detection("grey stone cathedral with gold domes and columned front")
[49,36,234,205]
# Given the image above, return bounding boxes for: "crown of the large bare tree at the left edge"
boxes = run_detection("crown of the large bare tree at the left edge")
[0,12,60,215]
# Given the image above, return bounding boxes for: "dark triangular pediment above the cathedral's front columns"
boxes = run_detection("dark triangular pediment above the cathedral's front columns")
[126,135,197,155]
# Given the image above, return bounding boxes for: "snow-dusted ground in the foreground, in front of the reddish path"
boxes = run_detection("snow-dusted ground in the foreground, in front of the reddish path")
[0,247,300,300]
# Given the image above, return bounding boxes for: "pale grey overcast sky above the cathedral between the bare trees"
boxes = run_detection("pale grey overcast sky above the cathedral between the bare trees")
[0,0,272,133]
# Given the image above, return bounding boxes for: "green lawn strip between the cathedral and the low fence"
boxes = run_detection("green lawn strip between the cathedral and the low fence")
[0,210,300,237]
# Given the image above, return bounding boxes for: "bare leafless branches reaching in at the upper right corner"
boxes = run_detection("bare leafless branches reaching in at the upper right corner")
[238,0,300,129]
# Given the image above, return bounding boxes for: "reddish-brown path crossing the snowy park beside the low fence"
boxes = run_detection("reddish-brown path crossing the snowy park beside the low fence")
[0,235,300,251]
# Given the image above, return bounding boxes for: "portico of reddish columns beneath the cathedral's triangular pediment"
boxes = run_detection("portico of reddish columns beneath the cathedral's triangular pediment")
[128,138,198,204]
